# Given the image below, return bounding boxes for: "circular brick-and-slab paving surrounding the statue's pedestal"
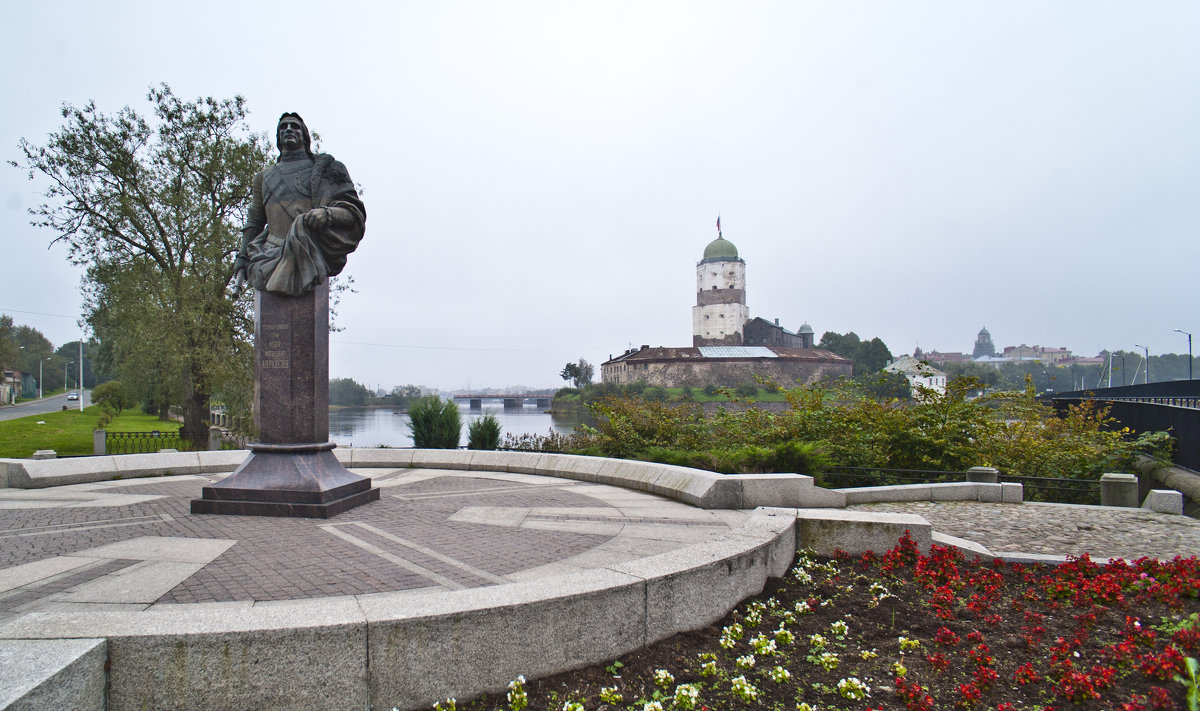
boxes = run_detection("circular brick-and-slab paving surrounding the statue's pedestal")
[0,468,746,620]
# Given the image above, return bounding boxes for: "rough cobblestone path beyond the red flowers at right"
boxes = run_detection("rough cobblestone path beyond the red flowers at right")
[846,501,1200,560]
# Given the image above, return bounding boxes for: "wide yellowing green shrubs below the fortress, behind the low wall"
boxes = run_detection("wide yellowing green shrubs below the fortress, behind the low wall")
[574,377,1170,478]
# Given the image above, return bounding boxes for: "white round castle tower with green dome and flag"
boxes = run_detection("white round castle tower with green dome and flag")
[691,221,750,346]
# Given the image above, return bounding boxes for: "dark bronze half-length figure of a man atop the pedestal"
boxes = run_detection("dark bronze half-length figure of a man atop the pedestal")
[234,113,367,297]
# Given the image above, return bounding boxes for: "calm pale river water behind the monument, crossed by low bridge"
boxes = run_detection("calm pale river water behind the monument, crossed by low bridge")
[329,402,584,448]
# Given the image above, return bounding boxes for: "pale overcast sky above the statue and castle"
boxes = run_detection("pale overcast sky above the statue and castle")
[0,0,1200,390]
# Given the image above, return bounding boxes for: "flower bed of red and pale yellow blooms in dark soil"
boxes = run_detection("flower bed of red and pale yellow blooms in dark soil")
[437,534,1200,711]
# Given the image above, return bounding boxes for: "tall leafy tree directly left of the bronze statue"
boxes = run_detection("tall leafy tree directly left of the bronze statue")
[13,84,270,437]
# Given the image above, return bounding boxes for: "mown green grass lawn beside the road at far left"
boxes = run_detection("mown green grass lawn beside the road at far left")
[0,406,179,459]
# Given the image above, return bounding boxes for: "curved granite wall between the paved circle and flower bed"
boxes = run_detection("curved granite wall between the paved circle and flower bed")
[0,510,796,710]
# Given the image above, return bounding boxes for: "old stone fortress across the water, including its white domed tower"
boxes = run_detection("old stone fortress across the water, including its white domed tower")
[600,229,853,388]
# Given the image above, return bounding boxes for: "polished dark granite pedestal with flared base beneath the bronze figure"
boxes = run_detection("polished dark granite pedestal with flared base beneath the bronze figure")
[192,283,379,518]
